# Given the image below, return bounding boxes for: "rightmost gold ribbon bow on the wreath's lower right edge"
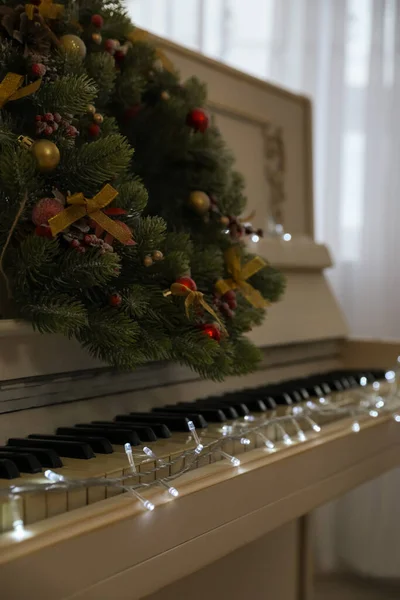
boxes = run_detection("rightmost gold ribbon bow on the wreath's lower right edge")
[215,246,269,308]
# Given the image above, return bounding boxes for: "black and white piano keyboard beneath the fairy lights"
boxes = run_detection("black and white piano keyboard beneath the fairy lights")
[0,370,385,532]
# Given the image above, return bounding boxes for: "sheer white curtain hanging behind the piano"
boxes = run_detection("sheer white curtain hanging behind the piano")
[129,0,400,577]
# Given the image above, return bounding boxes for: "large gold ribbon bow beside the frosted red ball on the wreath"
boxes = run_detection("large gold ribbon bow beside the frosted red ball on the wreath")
[49,183,132,244]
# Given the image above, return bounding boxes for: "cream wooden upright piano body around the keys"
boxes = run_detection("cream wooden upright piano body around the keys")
[0,34,400,600]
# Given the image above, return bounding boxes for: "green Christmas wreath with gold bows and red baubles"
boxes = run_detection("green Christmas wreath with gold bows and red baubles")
[0,0,283,379]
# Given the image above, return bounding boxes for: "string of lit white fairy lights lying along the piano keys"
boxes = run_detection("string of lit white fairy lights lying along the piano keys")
[0,371,400,539]
